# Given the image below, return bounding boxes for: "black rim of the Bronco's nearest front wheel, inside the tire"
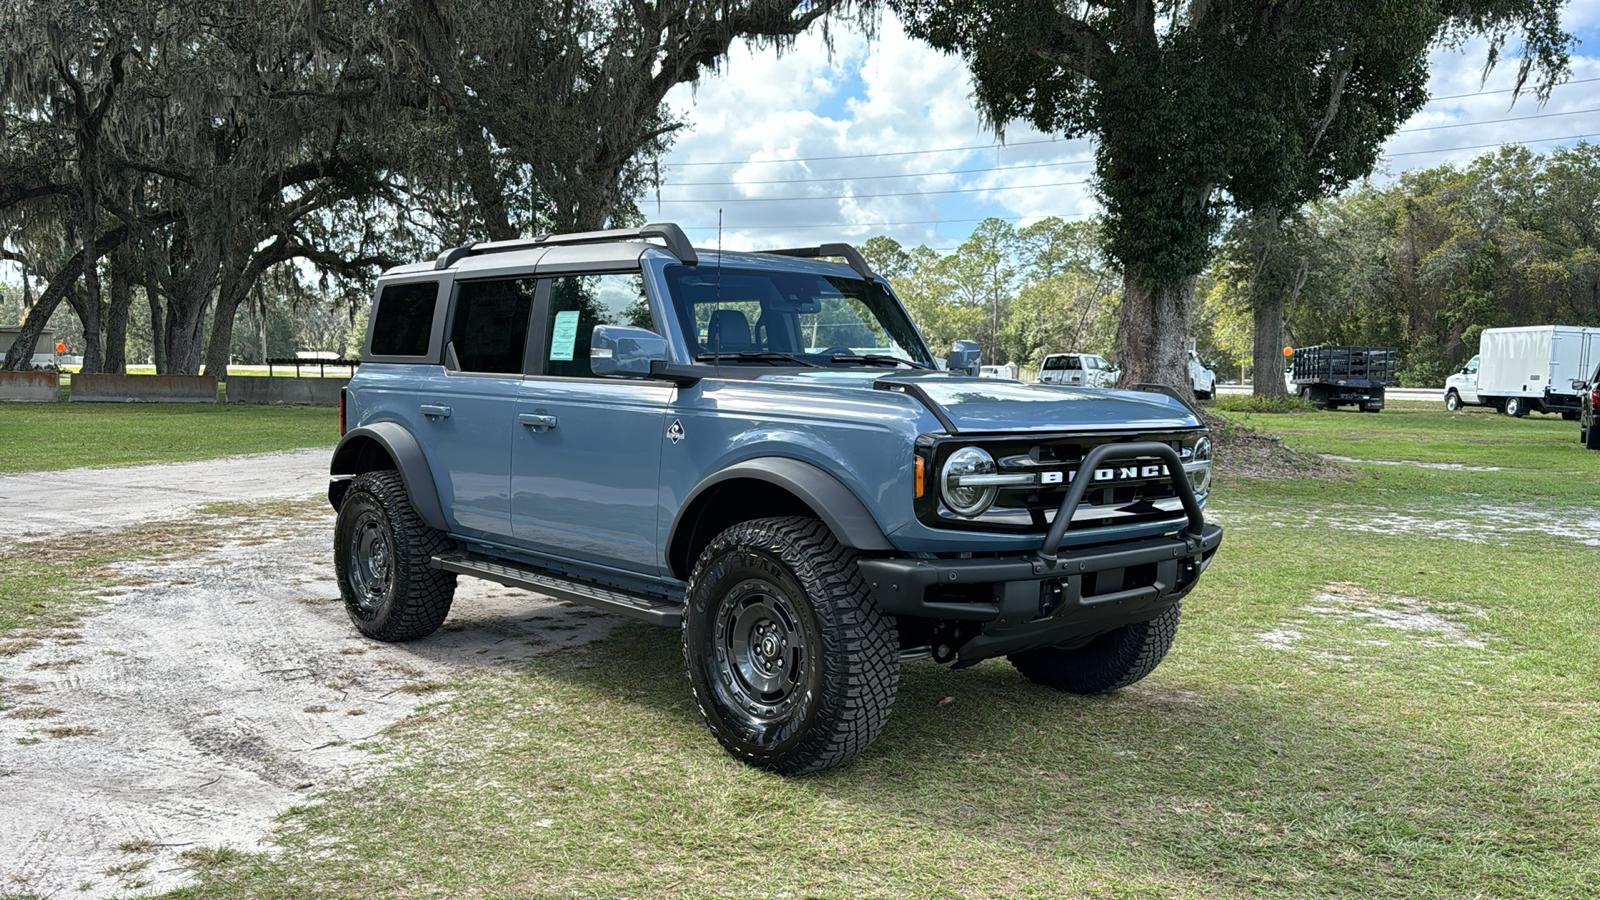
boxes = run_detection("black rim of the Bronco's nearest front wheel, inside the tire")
[712,578,810,730]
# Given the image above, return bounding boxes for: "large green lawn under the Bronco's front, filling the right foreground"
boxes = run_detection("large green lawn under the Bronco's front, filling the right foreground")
[3,405,1600,900]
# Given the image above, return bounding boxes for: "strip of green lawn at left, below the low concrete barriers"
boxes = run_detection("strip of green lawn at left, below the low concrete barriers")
[0,404,339,472]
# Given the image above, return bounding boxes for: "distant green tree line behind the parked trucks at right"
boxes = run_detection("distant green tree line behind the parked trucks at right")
[1197,143,1600,386]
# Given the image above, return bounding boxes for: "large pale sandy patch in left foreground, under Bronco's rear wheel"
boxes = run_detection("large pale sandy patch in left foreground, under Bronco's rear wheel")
[0,509,618,897]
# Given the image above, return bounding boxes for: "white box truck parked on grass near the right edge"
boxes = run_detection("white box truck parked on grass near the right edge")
[1445,325,1600,420]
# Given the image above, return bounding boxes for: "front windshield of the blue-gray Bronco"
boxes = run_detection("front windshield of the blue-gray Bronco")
[664,266,933,367]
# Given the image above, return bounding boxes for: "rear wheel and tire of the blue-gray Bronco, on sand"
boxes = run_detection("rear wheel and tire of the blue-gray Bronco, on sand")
[333,471,456,642]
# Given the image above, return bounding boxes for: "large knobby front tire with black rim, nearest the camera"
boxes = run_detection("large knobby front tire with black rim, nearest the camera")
[683,517,899,775]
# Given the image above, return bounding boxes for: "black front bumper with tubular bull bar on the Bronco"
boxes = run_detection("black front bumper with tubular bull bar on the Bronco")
[858,442,1222,665]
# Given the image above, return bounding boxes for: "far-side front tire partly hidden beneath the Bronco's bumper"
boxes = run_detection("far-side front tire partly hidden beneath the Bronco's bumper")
[1006,604,1182,693]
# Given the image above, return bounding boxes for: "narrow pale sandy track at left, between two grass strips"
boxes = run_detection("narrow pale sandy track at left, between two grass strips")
[0,448,333,543]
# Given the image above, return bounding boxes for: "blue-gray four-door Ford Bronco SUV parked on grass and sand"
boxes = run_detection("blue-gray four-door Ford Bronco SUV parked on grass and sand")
[328,224,1222,773]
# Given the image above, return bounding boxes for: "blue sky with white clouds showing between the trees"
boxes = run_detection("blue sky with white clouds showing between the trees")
[642,0,1600,250]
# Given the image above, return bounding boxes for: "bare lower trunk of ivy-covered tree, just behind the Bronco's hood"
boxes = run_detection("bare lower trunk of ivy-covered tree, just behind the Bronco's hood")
[1117,272,1195,400]
